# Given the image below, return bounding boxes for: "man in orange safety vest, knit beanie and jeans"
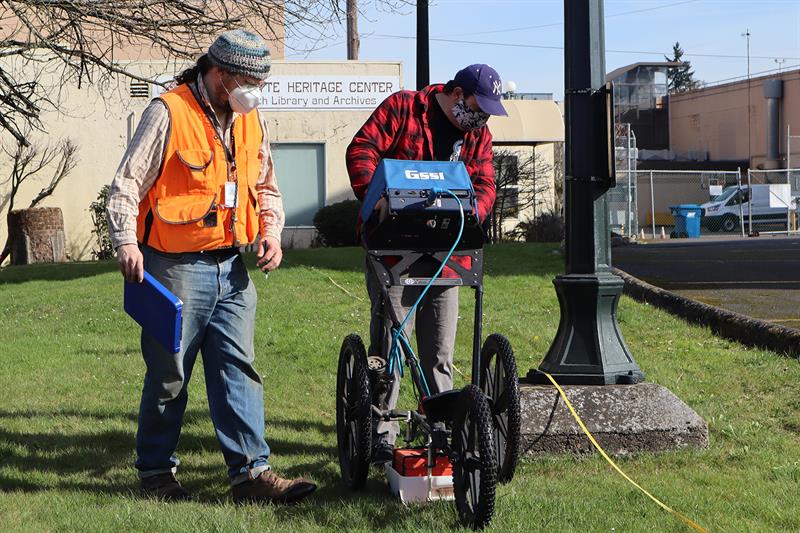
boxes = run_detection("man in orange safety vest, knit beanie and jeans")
[107,30,316,503]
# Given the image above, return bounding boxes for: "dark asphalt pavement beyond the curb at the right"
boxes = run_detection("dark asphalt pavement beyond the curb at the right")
[612,236,800,328]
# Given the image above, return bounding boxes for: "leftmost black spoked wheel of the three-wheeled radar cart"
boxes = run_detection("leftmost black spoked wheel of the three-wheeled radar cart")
[336,335,372,490]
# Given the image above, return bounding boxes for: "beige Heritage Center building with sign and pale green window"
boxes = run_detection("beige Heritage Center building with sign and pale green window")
[0,56,564,259]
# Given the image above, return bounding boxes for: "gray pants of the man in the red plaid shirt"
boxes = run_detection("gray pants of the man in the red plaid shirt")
[366,258,458,444]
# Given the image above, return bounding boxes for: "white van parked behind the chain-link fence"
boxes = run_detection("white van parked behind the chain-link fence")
[700,185,796,231]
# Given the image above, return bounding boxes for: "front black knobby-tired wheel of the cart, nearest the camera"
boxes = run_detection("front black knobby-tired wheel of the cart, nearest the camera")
[450,385,497,530]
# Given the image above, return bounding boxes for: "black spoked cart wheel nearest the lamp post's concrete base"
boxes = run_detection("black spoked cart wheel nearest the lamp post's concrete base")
[480,333,522,483]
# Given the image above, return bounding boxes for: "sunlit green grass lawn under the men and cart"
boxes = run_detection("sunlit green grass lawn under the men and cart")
[0,244,800,532]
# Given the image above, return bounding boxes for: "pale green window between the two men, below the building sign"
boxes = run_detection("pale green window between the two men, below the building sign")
[272,143,325,227]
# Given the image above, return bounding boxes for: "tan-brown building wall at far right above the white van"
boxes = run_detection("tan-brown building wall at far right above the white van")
[669,70,800,168]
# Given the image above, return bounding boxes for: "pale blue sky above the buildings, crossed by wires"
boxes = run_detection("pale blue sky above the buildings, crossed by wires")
[286,0,800,100]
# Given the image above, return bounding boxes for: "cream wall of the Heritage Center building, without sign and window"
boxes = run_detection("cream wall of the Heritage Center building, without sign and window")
[0,61,564,259]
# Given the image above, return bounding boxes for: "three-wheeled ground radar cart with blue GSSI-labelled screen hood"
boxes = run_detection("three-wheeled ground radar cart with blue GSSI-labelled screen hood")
[336,159,520,529]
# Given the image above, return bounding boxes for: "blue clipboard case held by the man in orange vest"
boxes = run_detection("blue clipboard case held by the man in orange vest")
[124,271,183,353]
